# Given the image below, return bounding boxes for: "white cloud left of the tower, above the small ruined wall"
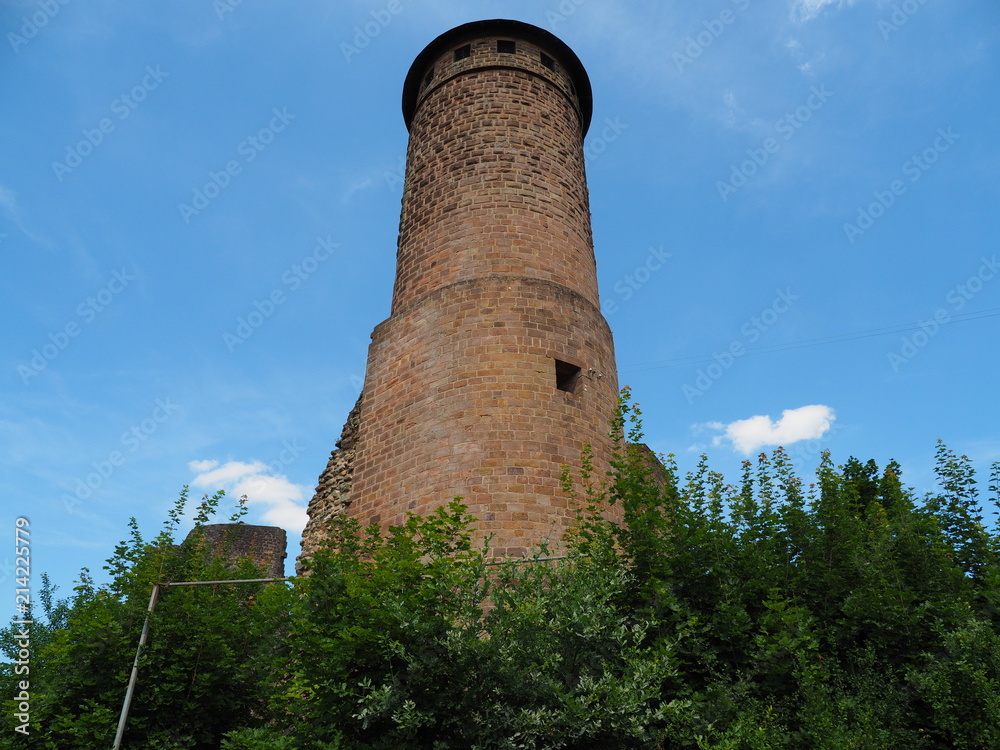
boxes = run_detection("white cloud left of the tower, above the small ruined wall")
[188,460,311,533]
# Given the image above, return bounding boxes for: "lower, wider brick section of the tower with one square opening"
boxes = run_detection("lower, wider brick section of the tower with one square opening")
[351,277,617,555]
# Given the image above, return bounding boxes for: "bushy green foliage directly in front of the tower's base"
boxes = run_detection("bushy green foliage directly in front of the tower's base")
[281,501,681,750]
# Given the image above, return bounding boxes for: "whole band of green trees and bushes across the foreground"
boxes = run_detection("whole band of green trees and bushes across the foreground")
[1,393,1000,750]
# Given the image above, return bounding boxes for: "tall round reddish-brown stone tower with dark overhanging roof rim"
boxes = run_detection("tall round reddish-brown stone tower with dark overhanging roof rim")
[303,20,618,555]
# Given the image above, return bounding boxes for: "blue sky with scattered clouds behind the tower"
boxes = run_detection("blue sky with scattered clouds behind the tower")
[0,0,1000,593]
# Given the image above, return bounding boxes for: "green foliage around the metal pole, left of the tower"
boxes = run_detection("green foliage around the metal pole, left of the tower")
[0,488,290,750]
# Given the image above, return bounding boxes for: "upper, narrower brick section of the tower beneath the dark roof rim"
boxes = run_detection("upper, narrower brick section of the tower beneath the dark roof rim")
[392,36,597,314]
